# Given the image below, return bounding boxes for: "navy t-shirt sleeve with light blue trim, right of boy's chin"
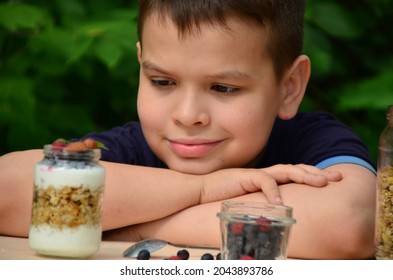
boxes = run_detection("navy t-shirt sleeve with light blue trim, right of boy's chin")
[258,112,375,172]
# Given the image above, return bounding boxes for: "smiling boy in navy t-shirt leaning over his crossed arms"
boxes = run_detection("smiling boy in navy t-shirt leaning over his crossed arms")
[0,0,375,259]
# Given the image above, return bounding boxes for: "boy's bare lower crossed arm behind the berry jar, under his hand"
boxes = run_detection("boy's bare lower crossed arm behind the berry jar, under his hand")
[130,164,375,259]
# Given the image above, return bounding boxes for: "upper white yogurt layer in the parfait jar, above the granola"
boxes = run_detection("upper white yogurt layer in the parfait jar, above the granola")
[34,164,105,188]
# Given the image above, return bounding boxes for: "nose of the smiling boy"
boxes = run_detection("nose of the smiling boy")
[172,93,210,127]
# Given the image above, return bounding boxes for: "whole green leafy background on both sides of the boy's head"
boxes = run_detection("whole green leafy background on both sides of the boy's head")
[0,0,393,164]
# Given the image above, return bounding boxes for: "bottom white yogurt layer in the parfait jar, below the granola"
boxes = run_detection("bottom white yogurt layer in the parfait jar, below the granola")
[29,225,101,258]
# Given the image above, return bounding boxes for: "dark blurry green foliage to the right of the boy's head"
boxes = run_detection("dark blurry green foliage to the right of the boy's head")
[301,0,393,162]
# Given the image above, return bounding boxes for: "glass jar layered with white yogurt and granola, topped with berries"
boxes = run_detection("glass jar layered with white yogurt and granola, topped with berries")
[29,145,105,258]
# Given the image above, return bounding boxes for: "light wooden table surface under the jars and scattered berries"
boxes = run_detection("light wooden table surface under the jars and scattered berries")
[0,236,219,260]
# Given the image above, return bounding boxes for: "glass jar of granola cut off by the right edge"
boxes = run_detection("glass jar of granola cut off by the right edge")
[375,105,393,260]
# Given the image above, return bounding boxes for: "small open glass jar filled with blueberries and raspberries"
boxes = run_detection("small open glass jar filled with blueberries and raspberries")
[217,201,296,260]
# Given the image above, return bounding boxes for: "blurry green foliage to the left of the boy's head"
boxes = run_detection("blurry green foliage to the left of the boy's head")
[0,0,139,154]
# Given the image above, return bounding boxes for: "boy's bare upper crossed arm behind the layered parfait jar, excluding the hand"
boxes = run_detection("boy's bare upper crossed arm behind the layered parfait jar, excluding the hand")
[0,150,201,237]
